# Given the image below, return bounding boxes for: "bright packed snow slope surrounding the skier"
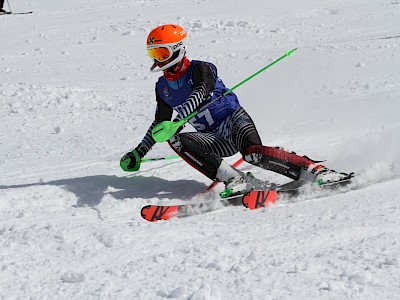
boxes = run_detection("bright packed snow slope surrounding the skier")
[0,0,400,299]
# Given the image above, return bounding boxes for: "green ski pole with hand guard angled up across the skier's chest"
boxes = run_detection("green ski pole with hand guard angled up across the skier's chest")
[152,48,297,143]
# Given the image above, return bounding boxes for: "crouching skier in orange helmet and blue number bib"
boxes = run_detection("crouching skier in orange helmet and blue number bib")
[120,24,349,195]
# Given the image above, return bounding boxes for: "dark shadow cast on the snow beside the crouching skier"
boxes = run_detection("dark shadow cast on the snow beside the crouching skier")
[0,175,206,207]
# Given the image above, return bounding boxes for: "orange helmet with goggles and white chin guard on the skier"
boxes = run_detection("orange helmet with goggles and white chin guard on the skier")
[147,24,186,72]
